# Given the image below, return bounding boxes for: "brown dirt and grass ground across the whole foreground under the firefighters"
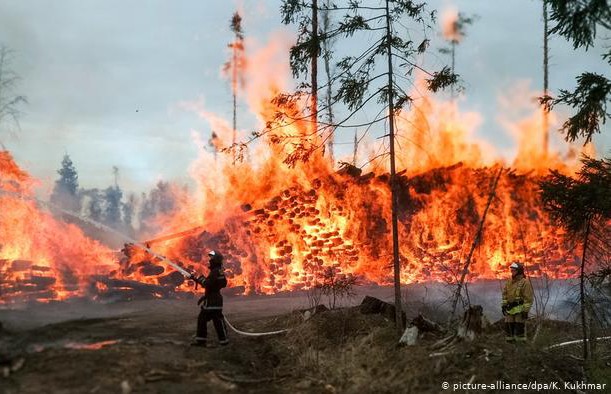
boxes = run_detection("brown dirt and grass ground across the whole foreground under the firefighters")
[0,288,611,393]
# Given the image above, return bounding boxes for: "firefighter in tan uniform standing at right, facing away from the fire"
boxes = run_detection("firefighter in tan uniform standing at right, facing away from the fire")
[501,262,533,342]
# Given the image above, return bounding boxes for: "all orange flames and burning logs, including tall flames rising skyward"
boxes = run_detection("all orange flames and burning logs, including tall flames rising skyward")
[0,1,592,304]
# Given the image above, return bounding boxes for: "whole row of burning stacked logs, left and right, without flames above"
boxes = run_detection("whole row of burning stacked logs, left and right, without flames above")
[0,146,579,303]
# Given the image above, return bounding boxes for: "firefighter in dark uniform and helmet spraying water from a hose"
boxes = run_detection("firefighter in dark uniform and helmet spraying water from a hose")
[191,250,229,347]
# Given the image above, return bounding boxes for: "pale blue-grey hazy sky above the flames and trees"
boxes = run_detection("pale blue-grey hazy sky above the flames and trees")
[0,0,611,195]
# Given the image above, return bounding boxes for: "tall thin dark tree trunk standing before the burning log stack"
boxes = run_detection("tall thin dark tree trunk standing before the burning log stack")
[386,0,403,334]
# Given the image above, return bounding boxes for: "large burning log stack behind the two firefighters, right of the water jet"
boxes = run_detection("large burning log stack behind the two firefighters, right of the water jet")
[117,164,579,293]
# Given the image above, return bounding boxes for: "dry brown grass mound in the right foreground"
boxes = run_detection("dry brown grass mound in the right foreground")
[250,308,611,393]
